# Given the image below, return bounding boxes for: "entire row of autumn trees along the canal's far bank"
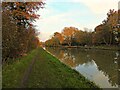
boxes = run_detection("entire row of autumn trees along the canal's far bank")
[45,9,120,46]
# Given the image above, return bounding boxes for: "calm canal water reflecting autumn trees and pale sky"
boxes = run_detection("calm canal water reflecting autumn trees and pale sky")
[46,48,120,88]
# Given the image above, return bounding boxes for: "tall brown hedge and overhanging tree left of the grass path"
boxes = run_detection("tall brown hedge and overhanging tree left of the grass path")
[2,1,44,62]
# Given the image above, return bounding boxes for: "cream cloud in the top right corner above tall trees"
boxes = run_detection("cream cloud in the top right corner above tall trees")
[79,0,118,14]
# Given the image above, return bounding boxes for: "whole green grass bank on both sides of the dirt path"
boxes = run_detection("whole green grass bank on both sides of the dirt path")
[3,48,98,88]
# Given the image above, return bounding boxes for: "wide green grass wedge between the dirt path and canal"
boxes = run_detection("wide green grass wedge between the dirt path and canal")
[26,48,97,88]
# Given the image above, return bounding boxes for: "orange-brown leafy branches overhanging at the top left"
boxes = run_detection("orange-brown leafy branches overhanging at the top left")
[2,1,44,27]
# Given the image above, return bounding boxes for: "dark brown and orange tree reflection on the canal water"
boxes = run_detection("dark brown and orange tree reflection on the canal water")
[47,48,120,86]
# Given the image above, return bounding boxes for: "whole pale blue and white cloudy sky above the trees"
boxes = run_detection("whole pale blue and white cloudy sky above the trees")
[34,0,119,41]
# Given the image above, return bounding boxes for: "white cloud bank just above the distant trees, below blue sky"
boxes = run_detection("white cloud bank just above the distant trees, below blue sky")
[36,10,99,41]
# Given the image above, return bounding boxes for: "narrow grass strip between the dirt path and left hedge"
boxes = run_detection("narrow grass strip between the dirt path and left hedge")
[2,49,37,88]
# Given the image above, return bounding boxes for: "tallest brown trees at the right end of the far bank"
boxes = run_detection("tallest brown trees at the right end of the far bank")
[94,9,119,45]
